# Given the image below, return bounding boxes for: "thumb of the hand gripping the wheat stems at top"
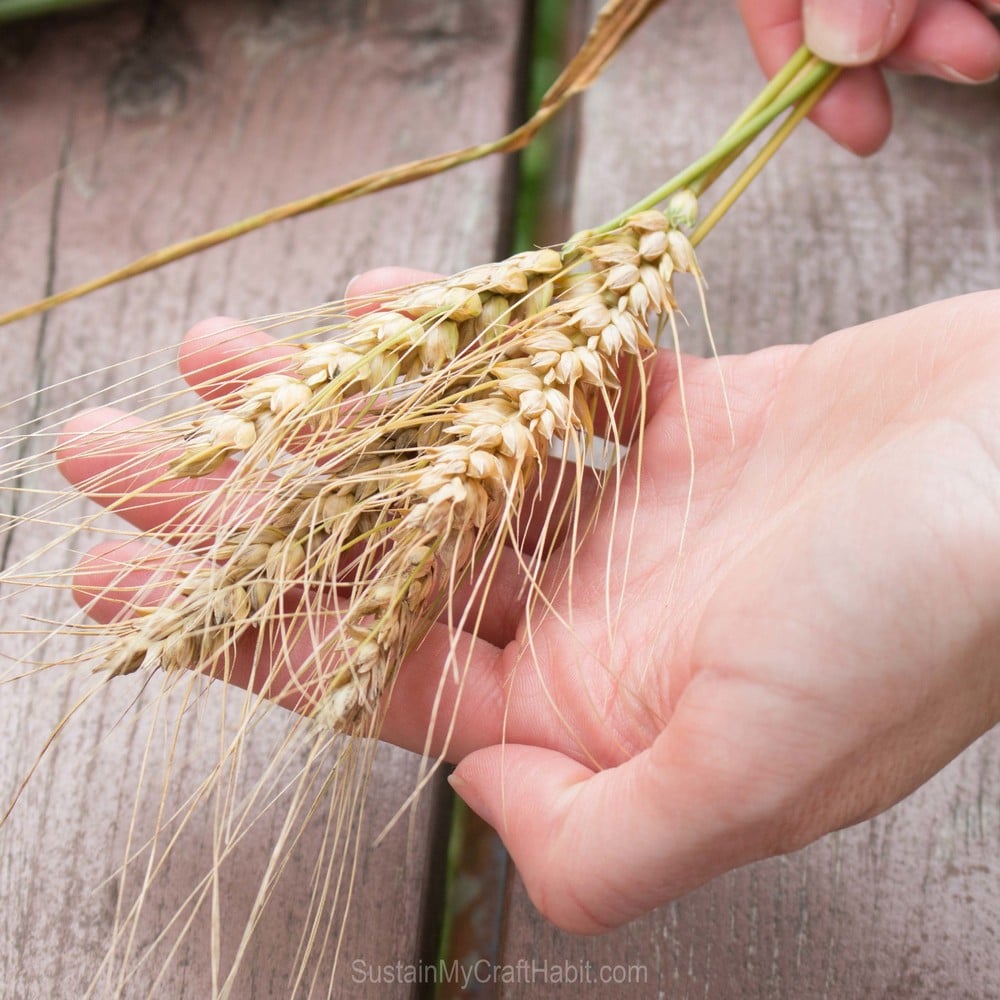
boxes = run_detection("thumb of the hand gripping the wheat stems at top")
[802,0,917,66]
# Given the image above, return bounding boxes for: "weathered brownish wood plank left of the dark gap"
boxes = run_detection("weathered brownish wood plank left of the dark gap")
[0,0,523,998]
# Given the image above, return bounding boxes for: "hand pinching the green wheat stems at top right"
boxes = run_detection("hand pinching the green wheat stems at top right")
[740,0,1000,155]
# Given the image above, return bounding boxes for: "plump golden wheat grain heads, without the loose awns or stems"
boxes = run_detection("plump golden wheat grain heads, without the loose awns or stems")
[82,203,698,732]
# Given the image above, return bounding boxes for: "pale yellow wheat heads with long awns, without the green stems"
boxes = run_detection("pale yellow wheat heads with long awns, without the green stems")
[4,203,698,997]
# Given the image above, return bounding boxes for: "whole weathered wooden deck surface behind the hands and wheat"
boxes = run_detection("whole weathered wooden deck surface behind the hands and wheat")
[0,0,1000,1000]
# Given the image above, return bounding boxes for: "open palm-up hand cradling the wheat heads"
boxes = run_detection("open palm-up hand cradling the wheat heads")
[61,271,1000,932]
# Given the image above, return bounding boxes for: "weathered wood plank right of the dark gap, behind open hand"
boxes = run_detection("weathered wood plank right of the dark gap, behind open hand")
[500,0,1000,1000]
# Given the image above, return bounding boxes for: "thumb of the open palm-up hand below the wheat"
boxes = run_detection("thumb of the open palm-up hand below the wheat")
[450,727,771,934]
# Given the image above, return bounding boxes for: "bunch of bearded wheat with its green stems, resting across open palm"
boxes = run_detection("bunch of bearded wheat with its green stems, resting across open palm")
[3,35,844,996]
